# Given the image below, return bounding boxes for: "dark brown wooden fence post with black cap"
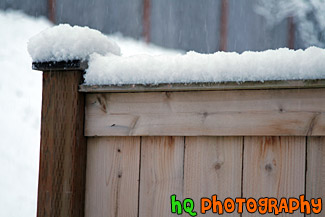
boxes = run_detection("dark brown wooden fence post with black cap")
[33,61,87,217]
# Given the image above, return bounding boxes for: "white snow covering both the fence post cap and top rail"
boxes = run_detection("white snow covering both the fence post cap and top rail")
[28,24,325,85]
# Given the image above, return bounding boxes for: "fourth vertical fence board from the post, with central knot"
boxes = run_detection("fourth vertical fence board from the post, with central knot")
[243,137,306,217]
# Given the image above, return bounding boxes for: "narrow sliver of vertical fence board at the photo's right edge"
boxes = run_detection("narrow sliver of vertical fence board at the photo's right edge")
[306,137,325,217]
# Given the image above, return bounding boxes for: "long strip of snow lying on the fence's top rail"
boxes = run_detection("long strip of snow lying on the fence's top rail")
[85,47,325,85]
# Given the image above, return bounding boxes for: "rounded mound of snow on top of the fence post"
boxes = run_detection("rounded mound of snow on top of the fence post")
[28,24,121,62]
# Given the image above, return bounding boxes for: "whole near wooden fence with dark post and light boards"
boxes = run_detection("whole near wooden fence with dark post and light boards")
[34,61,325,217]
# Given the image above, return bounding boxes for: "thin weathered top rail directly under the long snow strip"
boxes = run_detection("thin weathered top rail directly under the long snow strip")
[79,79,325,93]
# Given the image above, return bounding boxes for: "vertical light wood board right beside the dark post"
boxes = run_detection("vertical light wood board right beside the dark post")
[85,137,140,217]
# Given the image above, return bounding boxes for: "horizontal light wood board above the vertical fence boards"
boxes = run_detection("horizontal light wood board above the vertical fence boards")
[85,89,325,136]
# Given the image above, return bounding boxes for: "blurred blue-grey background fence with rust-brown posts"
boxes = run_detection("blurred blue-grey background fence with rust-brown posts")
[0,0,304,53]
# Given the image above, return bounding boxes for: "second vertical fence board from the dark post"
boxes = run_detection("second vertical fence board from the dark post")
[139,137,184,217]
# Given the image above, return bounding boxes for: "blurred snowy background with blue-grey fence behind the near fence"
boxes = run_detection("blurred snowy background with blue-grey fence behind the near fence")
[0,0,325,217]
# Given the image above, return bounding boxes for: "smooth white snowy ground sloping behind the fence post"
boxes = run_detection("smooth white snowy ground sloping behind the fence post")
[0,11,177,217]
